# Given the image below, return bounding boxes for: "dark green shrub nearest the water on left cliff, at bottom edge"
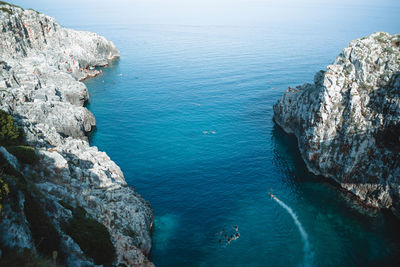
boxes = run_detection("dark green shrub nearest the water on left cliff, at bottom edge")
[63,206,115,266]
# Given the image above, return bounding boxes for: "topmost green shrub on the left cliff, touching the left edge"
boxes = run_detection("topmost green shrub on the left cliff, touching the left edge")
[0,110,23,146]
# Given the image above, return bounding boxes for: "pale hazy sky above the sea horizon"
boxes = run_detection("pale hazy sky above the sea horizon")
[12,0,400,29]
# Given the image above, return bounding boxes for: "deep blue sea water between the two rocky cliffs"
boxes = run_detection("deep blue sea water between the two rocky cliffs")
[15,1,400,266]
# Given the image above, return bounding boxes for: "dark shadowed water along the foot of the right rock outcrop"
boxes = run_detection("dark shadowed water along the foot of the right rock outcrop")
[271,124,400,266]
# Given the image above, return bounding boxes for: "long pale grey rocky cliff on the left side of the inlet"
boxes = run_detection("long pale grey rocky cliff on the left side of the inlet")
[0,2,153,266]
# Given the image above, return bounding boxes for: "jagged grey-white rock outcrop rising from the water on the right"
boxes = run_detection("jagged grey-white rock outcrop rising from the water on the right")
[274,33,400,218]
